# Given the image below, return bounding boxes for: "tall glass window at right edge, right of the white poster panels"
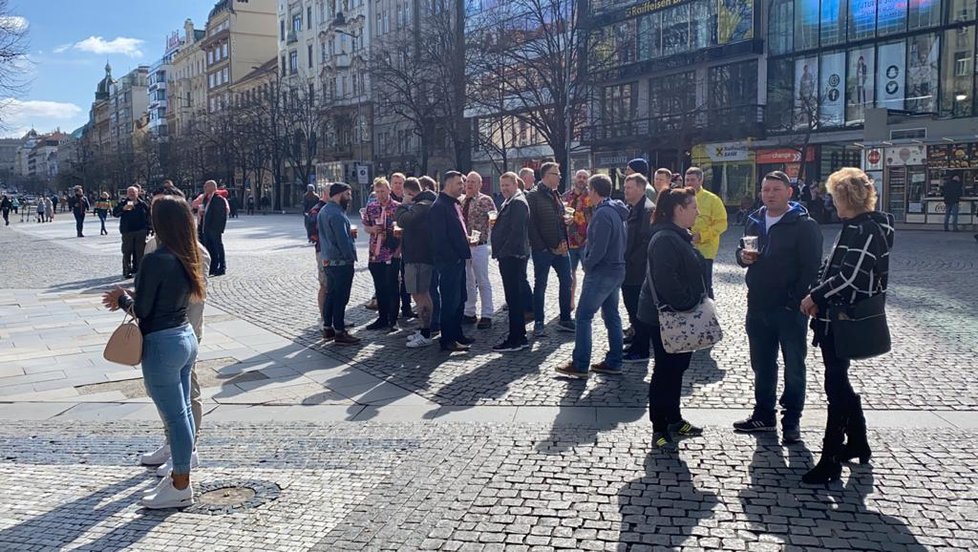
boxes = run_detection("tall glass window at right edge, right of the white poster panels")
[941,25,975,117]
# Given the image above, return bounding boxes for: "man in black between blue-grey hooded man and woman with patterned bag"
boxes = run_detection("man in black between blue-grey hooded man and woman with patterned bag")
[621,173,652,364]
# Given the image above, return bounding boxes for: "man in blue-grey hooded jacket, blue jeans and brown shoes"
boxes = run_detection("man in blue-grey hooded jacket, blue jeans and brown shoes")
[557,174,628,378]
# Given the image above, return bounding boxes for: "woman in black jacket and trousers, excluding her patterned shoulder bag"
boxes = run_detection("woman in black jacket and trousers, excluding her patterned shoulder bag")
[638,187,706,450]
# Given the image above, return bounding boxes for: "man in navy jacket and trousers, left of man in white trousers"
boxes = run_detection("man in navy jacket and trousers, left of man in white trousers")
[428,171,475,352]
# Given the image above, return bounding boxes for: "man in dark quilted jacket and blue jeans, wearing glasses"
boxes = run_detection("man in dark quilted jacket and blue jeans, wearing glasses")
[526,163,574,337]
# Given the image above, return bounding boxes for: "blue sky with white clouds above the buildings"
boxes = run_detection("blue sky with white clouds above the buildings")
[0,0,214,137]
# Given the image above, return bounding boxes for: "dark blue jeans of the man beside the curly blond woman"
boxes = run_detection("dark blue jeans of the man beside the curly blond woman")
[747,307,808,427]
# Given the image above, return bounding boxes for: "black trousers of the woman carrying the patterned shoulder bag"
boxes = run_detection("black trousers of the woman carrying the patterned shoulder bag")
[649,326,693,432]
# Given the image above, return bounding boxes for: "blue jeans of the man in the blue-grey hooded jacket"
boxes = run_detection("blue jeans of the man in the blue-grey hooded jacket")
[572,273,625,372]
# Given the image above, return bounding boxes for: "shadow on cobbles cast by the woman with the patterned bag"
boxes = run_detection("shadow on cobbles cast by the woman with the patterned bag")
[618,451,720,550]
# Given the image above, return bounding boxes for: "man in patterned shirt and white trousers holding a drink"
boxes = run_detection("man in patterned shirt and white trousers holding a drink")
[462,171,496,330]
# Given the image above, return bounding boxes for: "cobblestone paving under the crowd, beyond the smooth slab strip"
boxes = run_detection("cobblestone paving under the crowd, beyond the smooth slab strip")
[0,216,978,410]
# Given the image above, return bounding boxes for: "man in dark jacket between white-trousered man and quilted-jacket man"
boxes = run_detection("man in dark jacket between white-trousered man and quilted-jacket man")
[490,172,530,352]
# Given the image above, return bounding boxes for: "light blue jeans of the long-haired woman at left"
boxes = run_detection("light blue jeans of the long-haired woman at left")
[142,324,197,475]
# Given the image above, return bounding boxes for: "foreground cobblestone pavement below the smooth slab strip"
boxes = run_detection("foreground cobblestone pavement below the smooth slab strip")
[0,422,978,551]
